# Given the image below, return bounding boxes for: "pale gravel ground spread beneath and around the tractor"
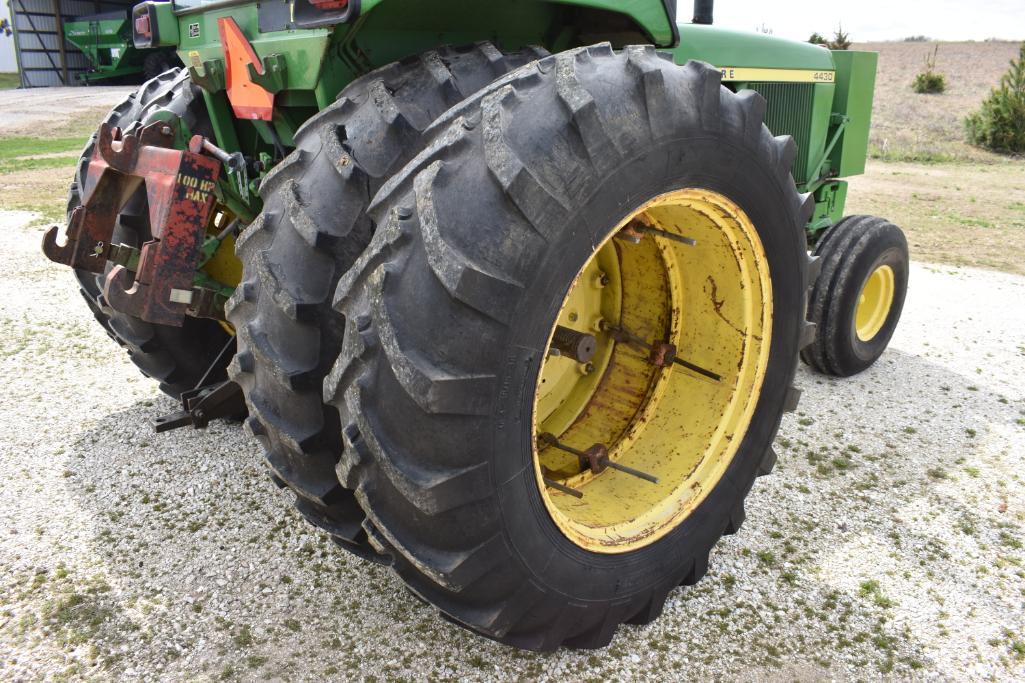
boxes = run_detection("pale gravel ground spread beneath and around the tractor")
[0,212,1025,681]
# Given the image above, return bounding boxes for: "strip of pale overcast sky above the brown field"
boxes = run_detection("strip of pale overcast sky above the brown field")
[678,0,1025,41]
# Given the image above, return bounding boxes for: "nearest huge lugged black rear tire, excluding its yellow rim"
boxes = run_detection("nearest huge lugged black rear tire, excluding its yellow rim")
[325,45,813,650]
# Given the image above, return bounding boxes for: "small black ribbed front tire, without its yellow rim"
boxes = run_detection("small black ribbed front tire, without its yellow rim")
[801,215,909,377]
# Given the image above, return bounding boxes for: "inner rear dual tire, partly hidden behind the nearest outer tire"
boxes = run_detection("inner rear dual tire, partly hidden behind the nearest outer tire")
[229,43,546,560]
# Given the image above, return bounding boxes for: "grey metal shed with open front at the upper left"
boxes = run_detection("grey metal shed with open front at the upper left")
[7,0,135,88]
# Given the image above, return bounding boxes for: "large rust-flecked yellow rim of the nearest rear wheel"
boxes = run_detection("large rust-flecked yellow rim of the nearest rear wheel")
[533,189,773,553]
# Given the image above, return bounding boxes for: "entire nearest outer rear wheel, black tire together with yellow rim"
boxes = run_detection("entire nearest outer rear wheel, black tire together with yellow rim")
[324,45,812,650]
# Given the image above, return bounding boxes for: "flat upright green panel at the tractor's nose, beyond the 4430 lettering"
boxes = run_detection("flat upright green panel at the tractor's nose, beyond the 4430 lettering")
[829,50,878,177]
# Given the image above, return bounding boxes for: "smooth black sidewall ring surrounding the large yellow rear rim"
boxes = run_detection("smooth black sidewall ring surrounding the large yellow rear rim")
[491,134,807,601]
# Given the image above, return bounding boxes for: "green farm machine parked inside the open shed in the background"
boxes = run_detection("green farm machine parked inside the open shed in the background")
[64,9,181,83]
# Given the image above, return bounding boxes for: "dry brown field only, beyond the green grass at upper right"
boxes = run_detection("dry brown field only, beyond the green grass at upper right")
[854,42,1021,162]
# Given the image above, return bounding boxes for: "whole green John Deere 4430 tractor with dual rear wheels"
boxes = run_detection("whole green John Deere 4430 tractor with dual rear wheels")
[44,0,908,650]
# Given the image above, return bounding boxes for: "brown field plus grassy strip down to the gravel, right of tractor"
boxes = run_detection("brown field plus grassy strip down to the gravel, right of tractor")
[847,42,1025,274]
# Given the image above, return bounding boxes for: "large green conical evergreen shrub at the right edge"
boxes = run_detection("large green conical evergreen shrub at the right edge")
[965,43,1025,154]
